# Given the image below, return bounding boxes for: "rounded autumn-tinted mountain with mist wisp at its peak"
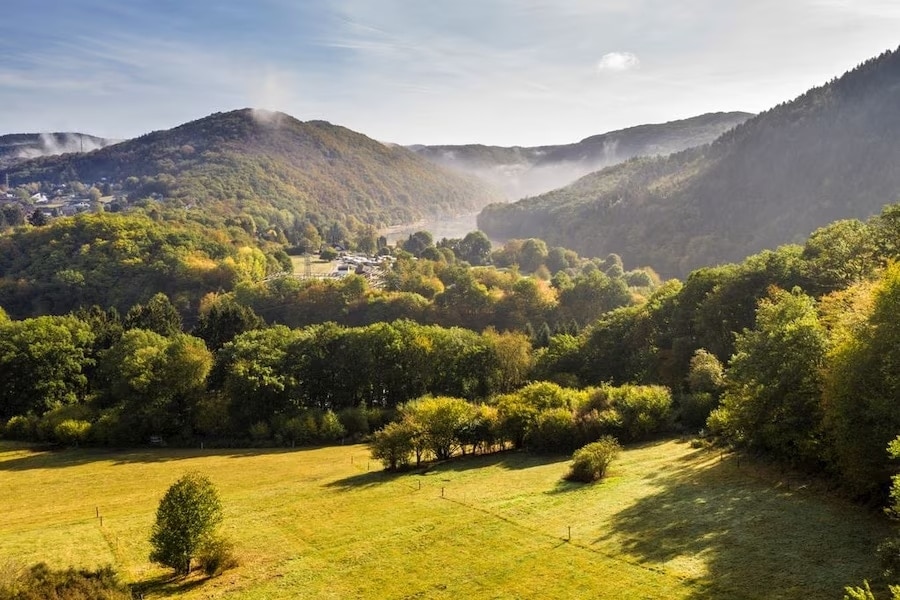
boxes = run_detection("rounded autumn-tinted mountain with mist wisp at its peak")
[0,109,501,228]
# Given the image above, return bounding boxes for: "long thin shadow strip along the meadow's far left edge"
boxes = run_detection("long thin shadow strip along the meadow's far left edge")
[0,445,315,471]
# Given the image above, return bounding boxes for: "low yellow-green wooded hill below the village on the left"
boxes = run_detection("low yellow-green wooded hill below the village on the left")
[0,213,290,316]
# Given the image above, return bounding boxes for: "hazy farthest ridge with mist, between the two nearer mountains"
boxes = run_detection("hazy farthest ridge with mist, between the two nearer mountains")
[410,112,753,200]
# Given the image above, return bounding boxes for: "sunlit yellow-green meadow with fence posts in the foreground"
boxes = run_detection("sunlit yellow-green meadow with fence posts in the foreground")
[0,441,889,599]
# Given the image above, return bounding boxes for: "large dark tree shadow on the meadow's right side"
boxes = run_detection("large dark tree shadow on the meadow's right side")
[596,453,889,598]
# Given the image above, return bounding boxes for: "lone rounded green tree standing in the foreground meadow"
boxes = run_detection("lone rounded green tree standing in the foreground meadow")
[150,473,222,575]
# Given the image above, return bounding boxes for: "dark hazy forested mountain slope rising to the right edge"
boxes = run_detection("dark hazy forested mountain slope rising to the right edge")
[478,46,900,275]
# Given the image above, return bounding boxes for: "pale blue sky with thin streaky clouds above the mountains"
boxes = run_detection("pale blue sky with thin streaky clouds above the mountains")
[0,0,900,146]
